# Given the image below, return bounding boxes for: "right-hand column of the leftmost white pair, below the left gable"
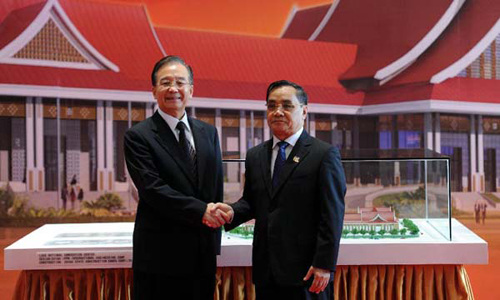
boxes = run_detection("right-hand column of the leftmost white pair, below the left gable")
[35,97,45,191]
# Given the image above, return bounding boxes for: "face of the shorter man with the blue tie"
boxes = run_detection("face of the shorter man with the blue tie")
[267,86,307,140]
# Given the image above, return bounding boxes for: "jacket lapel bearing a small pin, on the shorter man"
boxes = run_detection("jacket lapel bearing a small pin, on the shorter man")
[272,130,311,198]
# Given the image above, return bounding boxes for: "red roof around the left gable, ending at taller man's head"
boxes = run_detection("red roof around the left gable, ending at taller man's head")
[0,0,162,91]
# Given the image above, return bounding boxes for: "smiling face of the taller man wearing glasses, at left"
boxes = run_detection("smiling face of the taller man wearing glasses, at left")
[153,62,193,119]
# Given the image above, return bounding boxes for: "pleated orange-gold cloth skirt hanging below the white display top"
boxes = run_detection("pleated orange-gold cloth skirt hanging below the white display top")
[14,265,474,300]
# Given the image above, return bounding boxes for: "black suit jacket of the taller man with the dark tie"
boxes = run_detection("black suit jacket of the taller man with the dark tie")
[125,112,223,276]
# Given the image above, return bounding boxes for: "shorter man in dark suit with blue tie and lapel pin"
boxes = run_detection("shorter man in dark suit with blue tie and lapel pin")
[217,80,346,300]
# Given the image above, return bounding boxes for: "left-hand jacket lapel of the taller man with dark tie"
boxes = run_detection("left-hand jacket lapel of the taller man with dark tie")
[152,112,194,186]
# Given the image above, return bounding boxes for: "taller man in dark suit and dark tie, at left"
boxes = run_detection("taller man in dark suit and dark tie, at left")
[125,56,224,300]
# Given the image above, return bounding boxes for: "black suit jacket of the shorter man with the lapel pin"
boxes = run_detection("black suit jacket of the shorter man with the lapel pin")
[226,131,346,285]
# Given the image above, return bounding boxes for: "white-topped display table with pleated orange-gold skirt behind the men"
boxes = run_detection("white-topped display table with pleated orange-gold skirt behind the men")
[5,220,488,300]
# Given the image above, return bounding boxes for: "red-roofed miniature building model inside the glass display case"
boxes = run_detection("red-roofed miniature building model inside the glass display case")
[344,207,399,231]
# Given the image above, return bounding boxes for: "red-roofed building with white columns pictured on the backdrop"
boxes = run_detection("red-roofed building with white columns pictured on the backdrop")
[0,0,500,204]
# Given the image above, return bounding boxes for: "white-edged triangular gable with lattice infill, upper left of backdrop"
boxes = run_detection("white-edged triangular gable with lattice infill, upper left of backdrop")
[0,0,119,72]
